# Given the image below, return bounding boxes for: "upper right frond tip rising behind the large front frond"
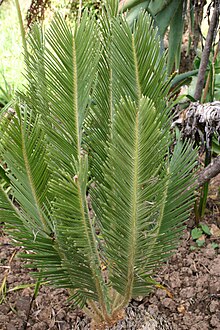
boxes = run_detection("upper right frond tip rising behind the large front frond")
[112,13,167,107]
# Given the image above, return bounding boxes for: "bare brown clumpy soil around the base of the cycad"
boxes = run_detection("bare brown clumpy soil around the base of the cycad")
[0,176,220,330]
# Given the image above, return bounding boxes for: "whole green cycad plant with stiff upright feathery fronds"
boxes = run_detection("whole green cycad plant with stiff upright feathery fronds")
[0,1,196,327]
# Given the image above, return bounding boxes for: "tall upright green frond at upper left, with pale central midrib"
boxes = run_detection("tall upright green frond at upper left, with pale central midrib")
[44,14,100,164]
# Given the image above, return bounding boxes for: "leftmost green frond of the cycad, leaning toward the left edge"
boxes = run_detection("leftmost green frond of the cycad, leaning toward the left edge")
[0,104,67,284]
